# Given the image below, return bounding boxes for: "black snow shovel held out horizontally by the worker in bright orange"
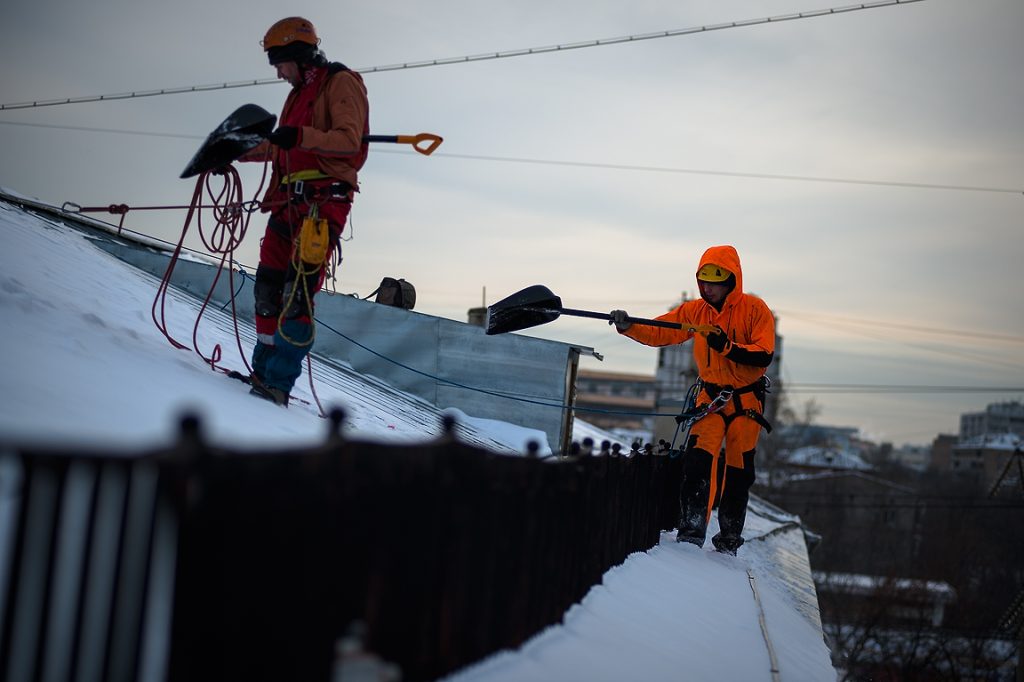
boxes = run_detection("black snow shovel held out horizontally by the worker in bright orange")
[485,285,715,335]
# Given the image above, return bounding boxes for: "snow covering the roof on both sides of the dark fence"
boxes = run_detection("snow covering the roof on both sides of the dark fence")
[0,191,835,681]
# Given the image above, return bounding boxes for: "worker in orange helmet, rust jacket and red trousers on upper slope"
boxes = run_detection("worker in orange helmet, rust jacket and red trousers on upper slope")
[241,16,370,406]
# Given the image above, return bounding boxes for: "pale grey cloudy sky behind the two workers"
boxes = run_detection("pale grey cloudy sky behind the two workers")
[0,0,1024,443]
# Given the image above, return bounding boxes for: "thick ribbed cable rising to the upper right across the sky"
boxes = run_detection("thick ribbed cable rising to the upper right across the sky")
[0,0,923,111]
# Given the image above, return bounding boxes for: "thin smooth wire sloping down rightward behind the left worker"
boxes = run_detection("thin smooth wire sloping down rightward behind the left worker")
[0,116,1024,195]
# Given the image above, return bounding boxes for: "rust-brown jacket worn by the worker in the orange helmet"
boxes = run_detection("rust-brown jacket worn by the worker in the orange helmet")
[240,65,370,196]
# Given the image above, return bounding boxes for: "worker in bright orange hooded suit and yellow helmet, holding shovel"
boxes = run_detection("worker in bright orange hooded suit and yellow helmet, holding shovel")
[610,246,775,555]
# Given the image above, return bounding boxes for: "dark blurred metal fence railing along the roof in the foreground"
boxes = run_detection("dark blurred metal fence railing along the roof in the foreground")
[0,411,679,680]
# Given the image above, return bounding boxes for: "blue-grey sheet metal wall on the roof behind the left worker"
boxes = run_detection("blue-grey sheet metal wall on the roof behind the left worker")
[97,236,594,452]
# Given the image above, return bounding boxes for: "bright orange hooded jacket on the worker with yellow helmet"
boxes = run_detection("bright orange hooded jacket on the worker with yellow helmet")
[622,246,775,388]
